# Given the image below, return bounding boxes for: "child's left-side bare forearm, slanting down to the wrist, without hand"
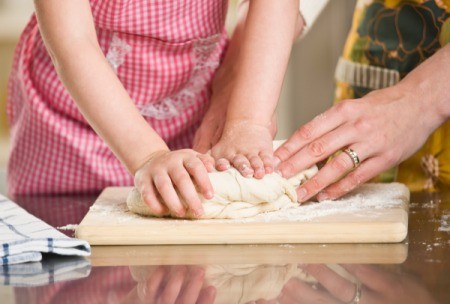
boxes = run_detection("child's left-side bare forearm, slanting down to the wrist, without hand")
[35,0,167,173]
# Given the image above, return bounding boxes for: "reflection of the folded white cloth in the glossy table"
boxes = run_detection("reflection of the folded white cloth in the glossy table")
[0,255,91,287]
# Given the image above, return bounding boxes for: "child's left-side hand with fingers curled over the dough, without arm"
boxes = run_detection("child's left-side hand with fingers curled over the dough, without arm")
[134,149,214,217]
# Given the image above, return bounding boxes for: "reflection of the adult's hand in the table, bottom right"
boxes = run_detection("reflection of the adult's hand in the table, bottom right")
[278,264,437,304]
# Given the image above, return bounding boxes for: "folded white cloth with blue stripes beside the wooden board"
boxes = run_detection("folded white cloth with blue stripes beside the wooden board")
[0,195,91,265]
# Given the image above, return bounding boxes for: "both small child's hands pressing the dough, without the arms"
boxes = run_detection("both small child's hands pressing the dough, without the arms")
[135,123,273,217]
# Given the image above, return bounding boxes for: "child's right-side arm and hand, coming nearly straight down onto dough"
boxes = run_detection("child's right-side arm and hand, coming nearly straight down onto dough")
[211,0,299,178]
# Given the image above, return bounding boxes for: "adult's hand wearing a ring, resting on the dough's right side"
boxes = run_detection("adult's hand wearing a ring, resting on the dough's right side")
[275,85,442,202]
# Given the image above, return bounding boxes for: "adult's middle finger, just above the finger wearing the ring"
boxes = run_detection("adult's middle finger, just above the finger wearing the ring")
[278,126,357,178]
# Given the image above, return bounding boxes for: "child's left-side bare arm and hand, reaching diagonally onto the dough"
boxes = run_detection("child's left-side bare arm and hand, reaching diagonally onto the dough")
[35,0,212,216]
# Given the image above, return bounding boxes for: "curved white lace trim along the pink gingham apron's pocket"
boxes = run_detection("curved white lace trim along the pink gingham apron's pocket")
[139,34,222,120]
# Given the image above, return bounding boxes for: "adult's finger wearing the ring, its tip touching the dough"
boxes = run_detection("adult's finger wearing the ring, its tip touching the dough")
[297,146,367,202]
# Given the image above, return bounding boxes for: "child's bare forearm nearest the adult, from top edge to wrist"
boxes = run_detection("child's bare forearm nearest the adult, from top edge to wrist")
[224,0,299,125]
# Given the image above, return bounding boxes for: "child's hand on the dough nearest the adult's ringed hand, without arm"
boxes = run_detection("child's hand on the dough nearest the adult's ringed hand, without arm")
[211,121,274,178]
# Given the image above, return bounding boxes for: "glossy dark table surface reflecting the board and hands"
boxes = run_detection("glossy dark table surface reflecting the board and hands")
[0,189,450,303]
